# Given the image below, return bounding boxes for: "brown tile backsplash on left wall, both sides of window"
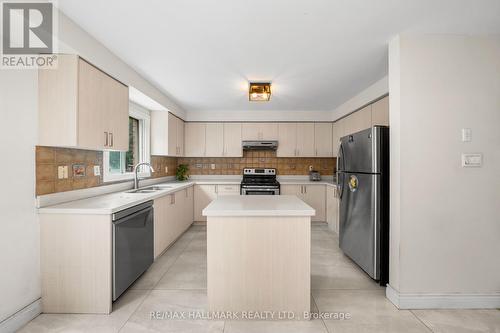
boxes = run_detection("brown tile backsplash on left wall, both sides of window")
[35,146,177,195]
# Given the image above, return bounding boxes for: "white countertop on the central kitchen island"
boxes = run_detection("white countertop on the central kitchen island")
[202,195,316,216]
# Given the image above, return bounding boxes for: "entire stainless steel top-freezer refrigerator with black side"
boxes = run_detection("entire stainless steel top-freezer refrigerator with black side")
[337,126,389,285]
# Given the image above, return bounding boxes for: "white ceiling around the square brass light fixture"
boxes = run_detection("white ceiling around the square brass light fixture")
[58,0,500,111]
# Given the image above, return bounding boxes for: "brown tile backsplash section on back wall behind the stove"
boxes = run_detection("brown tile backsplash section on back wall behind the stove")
[178,150,336,176]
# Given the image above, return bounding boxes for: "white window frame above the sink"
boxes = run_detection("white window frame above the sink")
[102,102,151,183]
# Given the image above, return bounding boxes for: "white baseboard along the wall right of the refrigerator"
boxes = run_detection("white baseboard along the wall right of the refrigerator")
[385,284,500,310]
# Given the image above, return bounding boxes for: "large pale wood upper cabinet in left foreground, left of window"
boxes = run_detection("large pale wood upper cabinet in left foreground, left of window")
[38,54,129,151]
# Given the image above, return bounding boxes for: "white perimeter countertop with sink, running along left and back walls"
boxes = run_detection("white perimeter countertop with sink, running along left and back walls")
[38,176,335,215]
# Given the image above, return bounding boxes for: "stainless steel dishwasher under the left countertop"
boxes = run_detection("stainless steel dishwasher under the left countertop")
[113,201,154,301]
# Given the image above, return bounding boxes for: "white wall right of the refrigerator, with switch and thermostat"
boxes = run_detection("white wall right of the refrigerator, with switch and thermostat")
[389,35,500,307]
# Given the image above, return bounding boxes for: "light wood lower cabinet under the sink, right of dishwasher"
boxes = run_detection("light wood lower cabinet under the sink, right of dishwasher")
[153,186,194,259]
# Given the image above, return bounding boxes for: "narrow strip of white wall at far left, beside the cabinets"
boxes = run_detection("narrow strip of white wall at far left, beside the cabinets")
[0,70,40,324]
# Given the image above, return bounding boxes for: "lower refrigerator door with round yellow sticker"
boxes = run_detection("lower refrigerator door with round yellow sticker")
[339,173,381,280]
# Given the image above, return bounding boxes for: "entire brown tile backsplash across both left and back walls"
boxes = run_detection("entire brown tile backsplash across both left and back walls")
[36,146,336,195]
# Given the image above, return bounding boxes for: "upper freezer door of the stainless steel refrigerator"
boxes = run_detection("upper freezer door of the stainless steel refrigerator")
[338,126,388,173]
